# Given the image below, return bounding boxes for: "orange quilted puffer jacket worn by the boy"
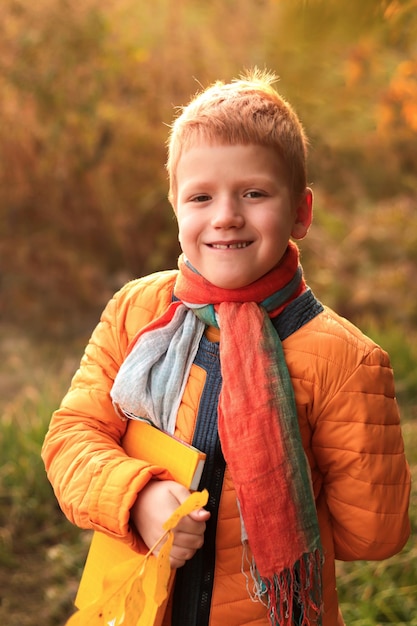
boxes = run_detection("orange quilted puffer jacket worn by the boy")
[42,271,410,626]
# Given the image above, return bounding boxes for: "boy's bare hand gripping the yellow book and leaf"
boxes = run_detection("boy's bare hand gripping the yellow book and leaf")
[131,480,210,569]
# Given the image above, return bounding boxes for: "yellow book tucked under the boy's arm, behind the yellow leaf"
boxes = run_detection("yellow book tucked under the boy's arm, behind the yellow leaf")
[75,420,206,609]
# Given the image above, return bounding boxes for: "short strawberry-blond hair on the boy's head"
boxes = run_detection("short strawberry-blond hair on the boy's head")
[166,68,308,204]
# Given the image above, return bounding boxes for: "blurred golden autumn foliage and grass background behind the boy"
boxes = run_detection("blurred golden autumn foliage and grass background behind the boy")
[0,0,417,626]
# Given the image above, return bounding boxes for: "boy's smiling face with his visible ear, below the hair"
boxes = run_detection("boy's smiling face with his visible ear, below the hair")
[174,142,312,289]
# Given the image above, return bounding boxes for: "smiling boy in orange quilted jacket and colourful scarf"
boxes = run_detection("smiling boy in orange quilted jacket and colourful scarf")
[43,70,410,626]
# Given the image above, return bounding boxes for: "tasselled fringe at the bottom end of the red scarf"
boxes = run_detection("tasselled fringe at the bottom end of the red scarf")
[242,542,323,626]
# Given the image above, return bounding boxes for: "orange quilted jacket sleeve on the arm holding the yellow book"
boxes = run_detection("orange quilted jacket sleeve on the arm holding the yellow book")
[42,280,174,549]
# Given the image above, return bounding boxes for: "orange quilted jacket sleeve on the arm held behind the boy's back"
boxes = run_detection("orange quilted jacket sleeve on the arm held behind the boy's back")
[312,340,411,560]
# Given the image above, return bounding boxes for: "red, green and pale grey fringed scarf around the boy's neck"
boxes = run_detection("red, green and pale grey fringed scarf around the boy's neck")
[111,242,322,626]
